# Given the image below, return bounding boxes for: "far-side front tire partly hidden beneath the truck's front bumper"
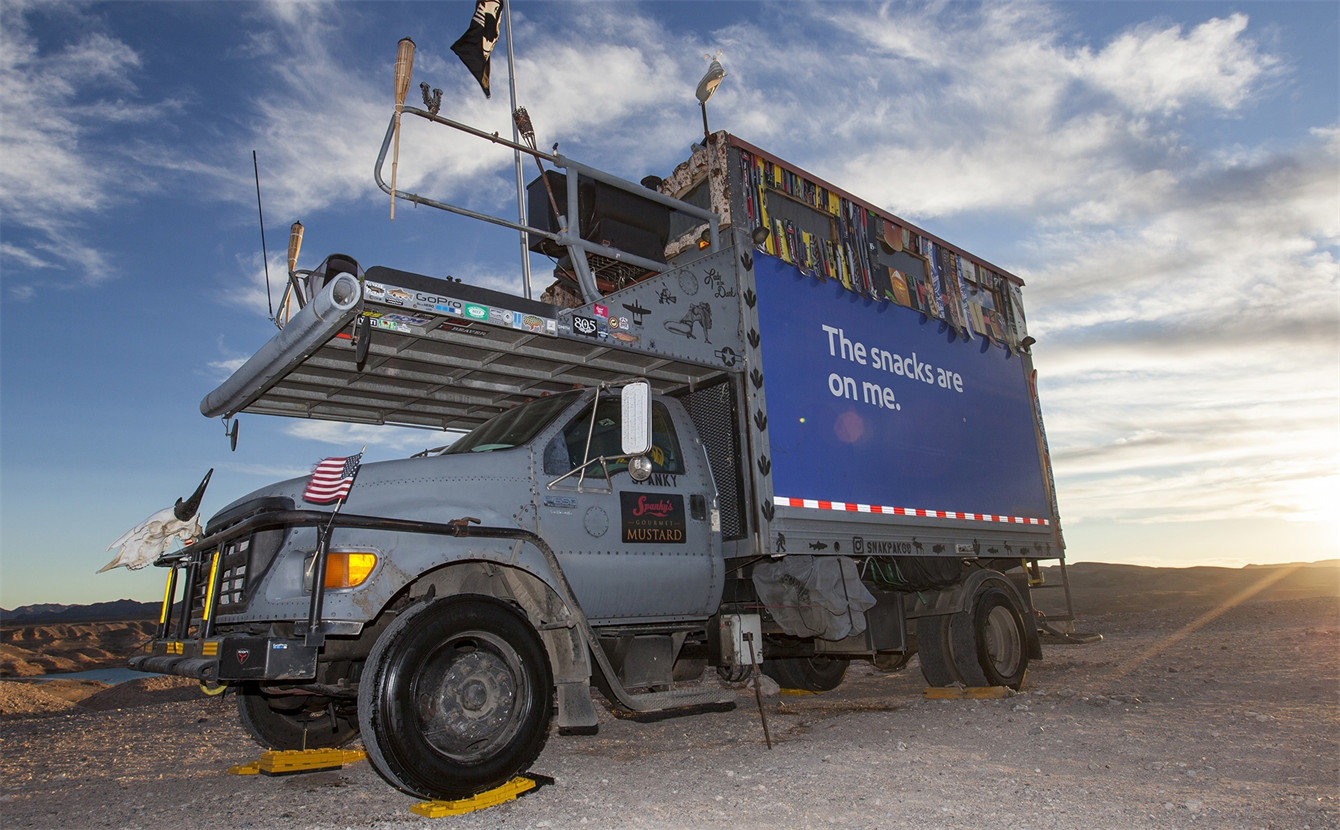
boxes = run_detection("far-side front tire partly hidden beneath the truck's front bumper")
[237,684,358,750]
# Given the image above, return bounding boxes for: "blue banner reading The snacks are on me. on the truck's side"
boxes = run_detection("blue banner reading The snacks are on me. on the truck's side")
[754,252,1051,519]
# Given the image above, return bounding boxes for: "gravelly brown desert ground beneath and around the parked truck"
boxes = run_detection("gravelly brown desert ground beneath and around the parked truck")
[0,598,1340,830]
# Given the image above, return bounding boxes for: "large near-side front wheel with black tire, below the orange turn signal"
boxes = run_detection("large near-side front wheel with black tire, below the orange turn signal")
[358,595,553,799]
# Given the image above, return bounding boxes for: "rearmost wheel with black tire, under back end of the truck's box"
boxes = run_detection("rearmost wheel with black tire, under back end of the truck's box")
[949,583,1028,689]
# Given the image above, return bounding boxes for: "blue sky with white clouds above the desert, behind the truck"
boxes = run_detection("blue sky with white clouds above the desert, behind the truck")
[0,0,1340,607]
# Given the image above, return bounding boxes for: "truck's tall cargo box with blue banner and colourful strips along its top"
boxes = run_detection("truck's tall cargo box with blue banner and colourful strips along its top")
[662,134,1063,558]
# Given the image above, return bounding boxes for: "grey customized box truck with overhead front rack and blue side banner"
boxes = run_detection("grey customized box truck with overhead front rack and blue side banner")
[130,53,1073,799]
